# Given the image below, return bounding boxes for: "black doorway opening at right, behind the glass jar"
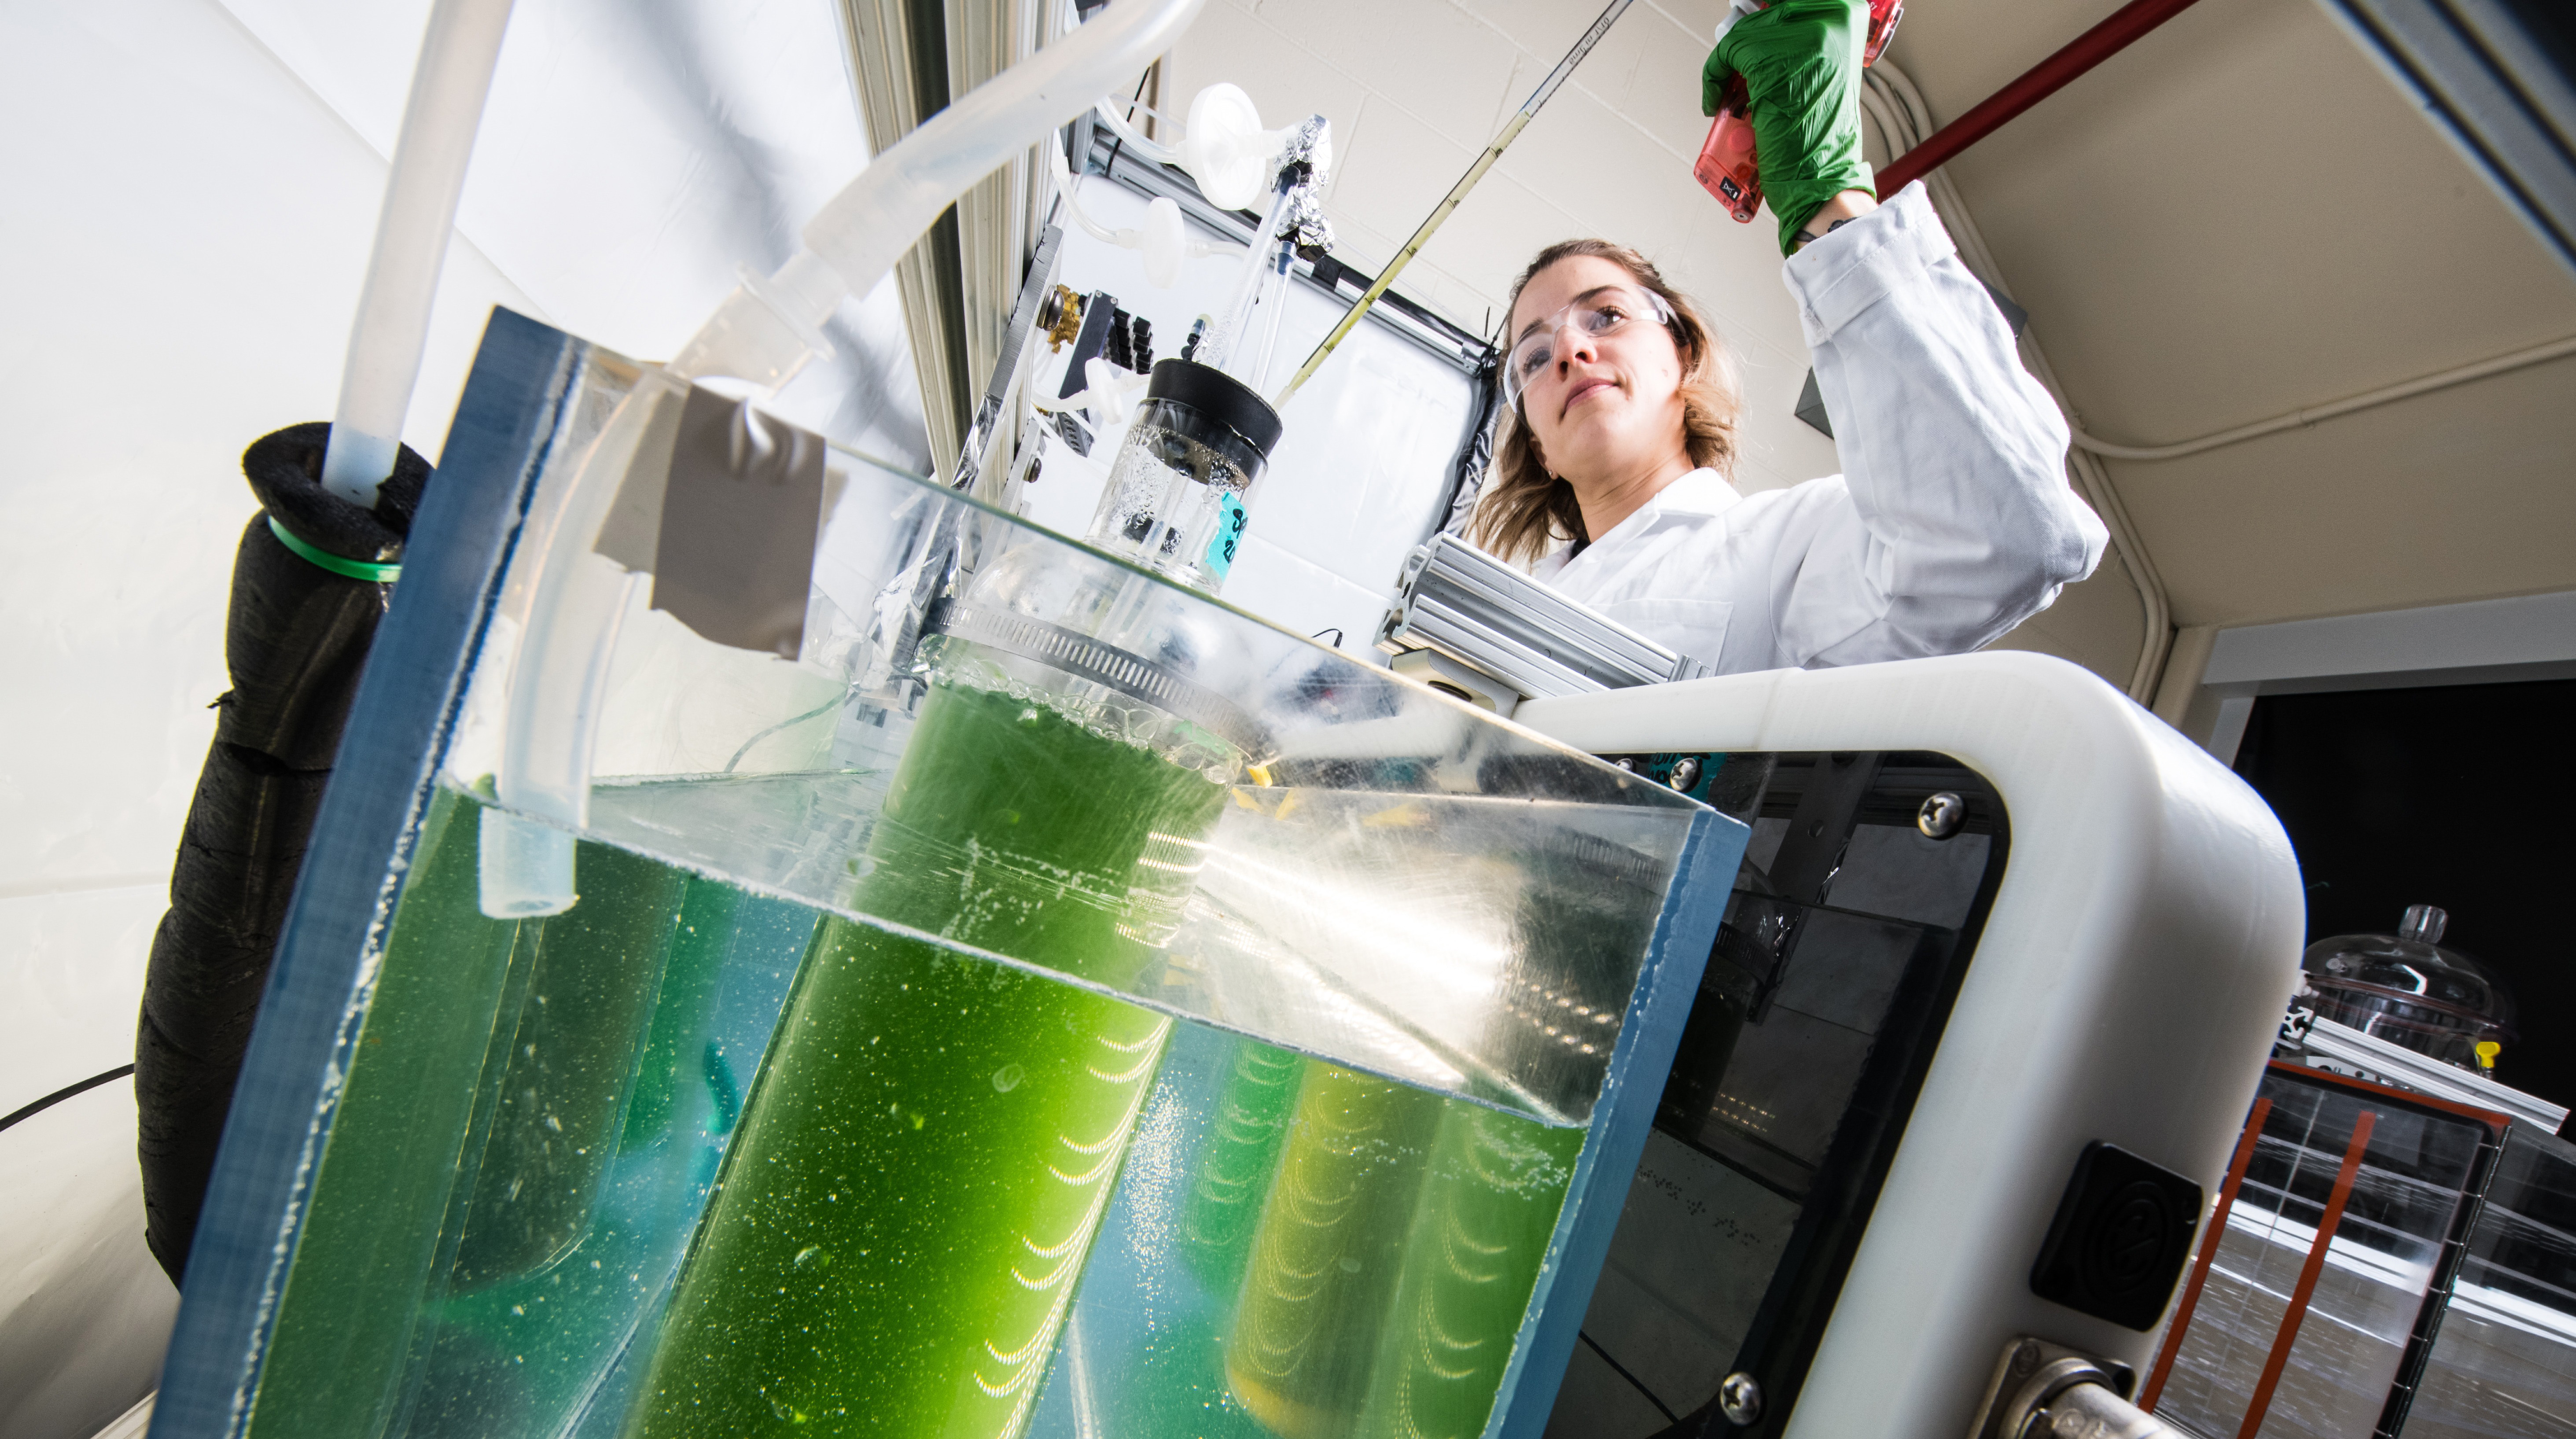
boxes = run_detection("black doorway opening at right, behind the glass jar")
[2236,680,2576,1107]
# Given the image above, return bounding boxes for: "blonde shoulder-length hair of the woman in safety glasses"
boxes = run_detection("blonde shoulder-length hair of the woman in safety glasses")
[1468,239,1744,564]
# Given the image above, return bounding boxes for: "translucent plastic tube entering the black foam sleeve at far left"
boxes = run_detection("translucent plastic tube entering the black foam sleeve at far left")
[322,0,510,504]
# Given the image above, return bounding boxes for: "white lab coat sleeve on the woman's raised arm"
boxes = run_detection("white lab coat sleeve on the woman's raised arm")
[1767,183,2110,664]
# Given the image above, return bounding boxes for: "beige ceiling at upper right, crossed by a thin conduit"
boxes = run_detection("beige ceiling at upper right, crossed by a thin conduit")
[1891,0,2576,626]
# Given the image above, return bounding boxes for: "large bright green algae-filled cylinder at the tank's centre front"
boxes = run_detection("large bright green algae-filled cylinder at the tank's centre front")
[629,680,1226,1439]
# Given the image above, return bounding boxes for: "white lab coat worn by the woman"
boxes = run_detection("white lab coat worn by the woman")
[1533,183,2110,674]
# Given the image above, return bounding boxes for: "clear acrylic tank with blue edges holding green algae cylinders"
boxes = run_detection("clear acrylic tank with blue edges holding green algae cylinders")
[155,314,1747,1439]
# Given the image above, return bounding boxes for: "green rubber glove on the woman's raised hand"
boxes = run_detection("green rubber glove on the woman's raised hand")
[1700,0,1875,255]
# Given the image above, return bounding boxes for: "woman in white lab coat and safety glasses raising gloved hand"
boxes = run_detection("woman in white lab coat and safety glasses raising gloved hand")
[1471,0,2107,674]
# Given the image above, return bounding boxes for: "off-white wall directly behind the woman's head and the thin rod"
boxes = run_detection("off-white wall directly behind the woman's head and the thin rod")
[1162,0,1842,489]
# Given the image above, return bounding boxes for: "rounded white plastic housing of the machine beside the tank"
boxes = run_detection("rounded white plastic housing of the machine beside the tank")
[1512,651,2306,1439]
